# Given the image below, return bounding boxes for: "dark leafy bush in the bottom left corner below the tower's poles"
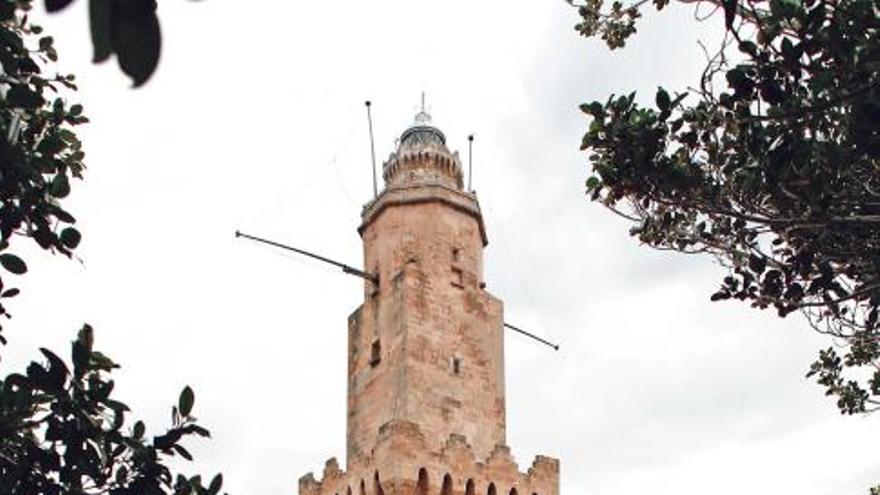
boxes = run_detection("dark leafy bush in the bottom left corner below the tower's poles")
[0,325,223,495]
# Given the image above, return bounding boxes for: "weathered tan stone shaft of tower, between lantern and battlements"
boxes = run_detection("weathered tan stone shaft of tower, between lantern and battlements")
[347,185,505,464]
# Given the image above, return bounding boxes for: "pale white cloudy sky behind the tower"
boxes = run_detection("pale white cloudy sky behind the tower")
[0,0,880,495]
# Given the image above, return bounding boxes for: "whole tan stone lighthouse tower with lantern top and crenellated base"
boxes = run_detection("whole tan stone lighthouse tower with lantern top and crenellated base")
[299,110,559,495]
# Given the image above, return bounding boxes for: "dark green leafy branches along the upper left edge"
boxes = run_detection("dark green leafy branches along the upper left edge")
[0,0,88,343]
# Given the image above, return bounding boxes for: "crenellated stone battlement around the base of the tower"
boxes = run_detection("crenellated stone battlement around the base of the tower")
[299,421,559,495]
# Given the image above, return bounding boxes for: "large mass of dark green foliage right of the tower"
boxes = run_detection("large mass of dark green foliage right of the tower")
[577,0,880,422]
